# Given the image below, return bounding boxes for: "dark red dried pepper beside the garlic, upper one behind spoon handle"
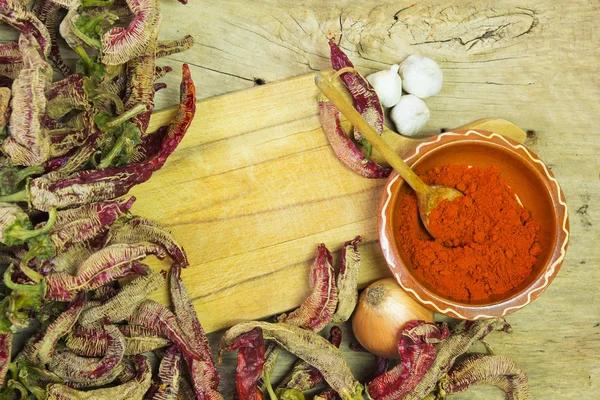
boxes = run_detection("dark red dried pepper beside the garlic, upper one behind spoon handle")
[329,39,384,152]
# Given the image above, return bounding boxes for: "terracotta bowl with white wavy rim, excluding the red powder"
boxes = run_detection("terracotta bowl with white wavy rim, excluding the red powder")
[379,130,569,320]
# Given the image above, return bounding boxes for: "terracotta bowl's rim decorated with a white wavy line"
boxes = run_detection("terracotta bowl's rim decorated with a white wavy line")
[378,129,570,320]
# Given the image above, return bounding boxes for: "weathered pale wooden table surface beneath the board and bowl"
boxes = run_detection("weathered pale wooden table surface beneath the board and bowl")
[0,0,600,399]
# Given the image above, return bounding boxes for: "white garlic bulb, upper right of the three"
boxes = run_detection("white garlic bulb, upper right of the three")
[400,54,444,99]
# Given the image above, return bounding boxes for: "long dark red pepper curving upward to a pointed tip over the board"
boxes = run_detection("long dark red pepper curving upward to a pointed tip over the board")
[0,64,196,211]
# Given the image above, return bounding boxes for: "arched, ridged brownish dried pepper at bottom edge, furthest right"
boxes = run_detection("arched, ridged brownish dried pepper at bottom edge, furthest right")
[438,355,531,400]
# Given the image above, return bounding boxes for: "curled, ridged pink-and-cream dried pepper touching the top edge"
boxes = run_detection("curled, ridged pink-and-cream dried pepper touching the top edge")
[101,0,161,65]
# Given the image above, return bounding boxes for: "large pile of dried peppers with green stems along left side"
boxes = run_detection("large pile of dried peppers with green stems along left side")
[0,0,222,400]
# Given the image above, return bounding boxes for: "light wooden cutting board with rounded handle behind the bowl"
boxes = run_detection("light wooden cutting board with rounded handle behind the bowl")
[131,74,525,332]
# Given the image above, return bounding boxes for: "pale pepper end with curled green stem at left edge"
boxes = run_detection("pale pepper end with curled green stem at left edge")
[0,203,57,246]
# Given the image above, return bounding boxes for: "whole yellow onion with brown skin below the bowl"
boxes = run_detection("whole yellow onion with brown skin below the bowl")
[352,278,433,358]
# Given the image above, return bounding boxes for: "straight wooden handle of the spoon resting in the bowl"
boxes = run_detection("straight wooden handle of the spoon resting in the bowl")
[315,74,429,194]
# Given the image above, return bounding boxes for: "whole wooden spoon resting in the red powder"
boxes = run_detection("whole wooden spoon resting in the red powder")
[315,74,463,235]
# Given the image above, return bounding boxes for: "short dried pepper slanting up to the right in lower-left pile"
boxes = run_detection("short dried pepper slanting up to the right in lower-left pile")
[26,293,85,364]
